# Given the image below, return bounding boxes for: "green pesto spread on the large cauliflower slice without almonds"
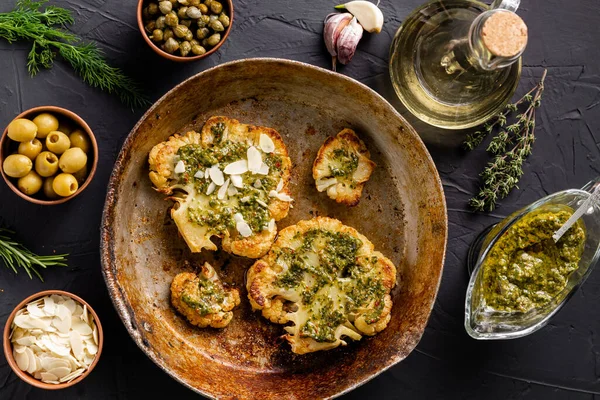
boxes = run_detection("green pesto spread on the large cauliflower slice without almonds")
[275,229,386,342]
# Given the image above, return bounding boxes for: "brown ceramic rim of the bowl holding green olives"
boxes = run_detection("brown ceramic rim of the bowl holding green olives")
[0,106,98,206]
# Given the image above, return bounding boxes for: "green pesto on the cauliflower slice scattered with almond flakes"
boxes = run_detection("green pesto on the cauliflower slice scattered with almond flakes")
[177,138,282,234]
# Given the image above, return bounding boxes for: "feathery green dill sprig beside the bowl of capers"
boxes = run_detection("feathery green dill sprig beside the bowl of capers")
[0,0,148,107]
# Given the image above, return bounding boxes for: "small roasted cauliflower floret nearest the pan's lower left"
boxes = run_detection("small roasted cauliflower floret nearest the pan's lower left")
[171,263,240,328]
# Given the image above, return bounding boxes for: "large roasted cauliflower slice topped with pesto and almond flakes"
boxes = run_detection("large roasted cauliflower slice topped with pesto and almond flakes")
[148,117,292,258]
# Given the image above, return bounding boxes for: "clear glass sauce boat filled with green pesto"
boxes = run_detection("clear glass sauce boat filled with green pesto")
[465,177,600,340]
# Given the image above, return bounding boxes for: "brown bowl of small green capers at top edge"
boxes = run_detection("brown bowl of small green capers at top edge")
[137,0,233,62]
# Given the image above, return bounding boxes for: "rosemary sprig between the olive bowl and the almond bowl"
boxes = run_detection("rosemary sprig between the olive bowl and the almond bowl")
[0,228,68,282]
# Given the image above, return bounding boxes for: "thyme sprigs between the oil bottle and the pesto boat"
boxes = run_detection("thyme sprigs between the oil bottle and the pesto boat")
[464,70,547,211]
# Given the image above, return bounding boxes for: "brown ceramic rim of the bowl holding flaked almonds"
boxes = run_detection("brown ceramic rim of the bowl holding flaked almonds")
[2,290,104,390]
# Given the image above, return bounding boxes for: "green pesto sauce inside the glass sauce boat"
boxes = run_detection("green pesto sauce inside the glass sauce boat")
[482,207,586,312]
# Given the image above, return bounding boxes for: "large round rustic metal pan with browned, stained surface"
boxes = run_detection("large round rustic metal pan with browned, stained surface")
[101,59,447,399]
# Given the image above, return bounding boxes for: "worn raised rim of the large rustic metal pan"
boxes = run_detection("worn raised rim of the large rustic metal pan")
[100,58,448,399]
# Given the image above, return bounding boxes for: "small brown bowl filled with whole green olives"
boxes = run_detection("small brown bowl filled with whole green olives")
[0,106,98,205]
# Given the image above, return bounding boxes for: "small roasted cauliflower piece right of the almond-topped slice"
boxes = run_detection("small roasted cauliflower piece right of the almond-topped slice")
[313,129,375,207]
